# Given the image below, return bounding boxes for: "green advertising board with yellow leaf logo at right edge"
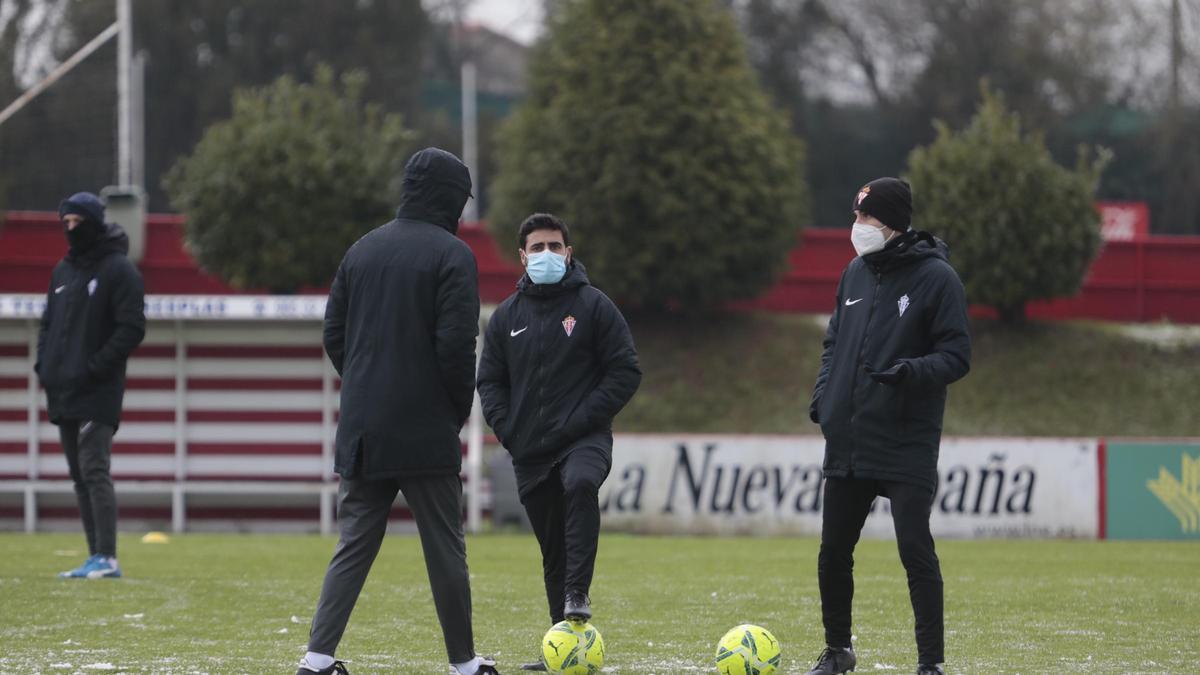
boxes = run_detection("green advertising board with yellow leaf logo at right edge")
[1104,442,1200,540]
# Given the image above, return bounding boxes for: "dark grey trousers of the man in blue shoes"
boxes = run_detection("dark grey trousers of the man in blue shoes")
[59,419,116,557]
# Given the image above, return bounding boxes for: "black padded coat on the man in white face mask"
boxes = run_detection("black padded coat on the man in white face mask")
[809,232,971,488]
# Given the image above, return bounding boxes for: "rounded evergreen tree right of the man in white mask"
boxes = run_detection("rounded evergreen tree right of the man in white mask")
[908,86,1111,323]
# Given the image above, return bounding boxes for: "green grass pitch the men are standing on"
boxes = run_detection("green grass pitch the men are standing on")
[0,534,1200,675]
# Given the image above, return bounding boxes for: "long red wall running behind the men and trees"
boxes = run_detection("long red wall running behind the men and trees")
[0,211,1200,323]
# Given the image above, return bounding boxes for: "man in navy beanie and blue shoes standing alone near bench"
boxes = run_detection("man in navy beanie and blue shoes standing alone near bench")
[34,192,146,579]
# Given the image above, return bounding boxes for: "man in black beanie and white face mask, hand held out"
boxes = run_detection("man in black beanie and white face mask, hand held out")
[809,178,971,675]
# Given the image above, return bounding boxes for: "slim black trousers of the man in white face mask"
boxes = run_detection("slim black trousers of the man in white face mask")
[817,478,944,664]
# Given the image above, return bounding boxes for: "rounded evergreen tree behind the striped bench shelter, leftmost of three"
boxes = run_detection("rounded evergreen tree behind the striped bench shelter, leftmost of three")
[164,66,410,292]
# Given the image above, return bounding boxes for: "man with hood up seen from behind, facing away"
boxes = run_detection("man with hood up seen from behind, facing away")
[298,148,496,675]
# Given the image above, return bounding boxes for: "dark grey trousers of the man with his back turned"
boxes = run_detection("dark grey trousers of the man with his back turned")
[308,474,475,663]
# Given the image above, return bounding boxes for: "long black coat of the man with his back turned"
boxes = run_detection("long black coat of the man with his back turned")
[324,211,479,479]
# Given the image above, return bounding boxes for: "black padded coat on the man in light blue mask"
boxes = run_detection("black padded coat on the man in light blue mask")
[479,261,642,494]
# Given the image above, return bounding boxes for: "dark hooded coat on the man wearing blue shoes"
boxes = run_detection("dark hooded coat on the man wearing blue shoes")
[34,225,146,428]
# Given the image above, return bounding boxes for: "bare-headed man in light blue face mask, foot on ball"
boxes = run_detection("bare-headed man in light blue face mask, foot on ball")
[478,214,642,670]
